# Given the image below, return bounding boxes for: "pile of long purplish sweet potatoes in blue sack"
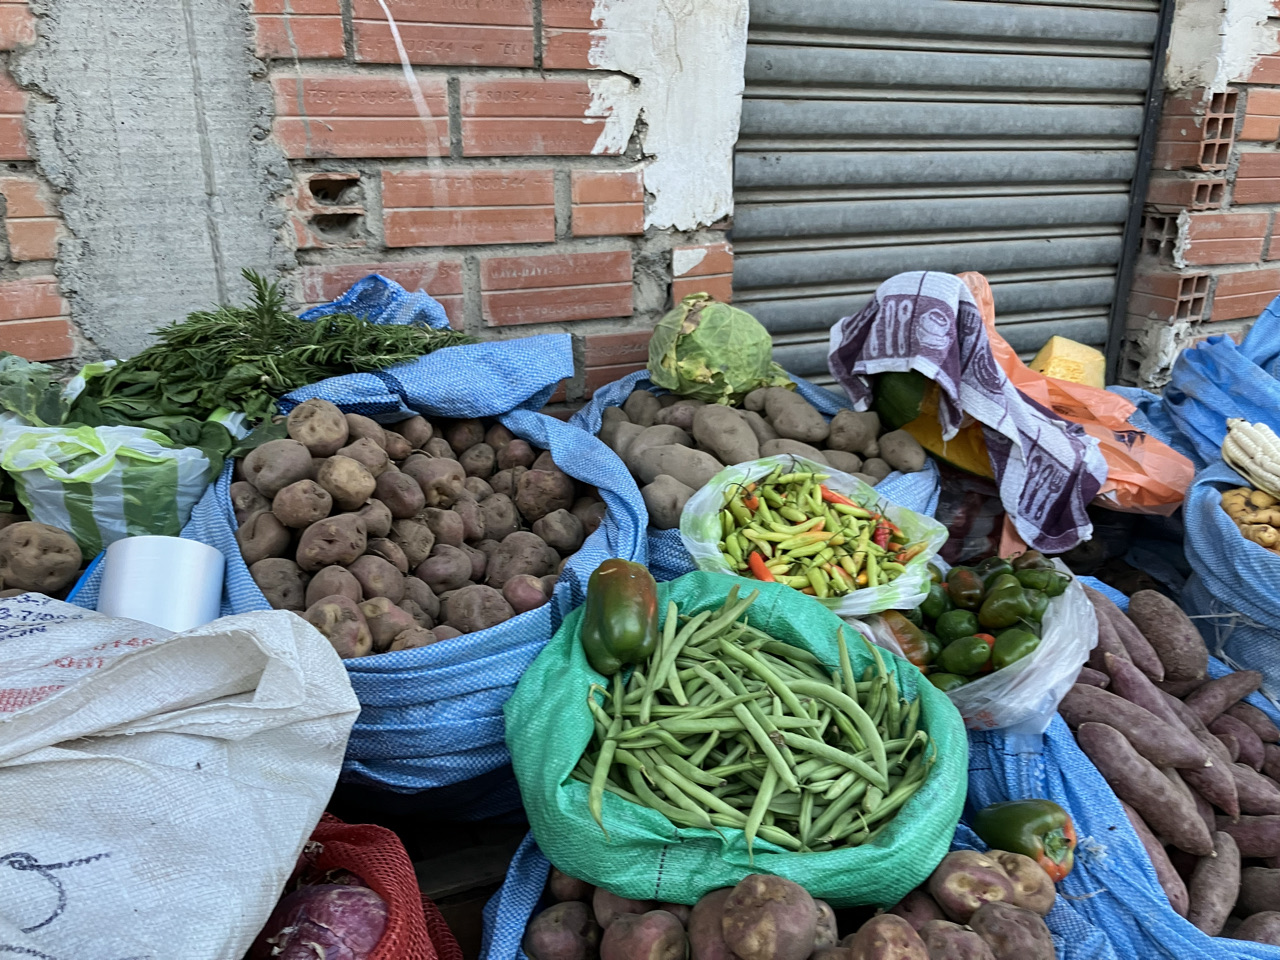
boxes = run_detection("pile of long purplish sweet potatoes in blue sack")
[1059,590,1280,945]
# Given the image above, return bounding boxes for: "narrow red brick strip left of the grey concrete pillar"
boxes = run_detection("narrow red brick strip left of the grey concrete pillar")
[0,0,76,360]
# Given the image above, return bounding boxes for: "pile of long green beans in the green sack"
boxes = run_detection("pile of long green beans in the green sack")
[572,586,937,854]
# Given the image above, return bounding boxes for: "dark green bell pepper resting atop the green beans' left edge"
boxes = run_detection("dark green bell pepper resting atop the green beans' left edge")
[581,558,658,677]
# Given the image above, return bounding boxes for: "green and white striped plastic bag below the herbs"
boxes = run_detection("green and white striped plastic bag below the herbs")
[0,417,212,557]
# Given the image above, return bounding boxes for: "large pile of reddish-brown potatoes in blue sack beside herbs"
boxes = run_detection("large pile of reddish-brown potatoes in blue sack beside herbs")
[230,399,605,658]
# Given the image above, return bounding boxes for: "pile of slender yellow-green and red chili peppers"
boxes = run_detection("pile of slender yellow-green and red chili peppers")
[719,466,924,598]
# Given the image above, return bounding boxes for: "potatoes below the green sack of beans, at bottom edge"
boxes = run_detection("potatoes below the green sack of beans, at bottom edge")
[521,850,1057,960]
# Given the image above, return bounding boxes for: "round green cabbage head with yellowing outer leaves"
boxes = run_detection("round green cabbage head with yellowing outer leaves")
[649,293,795,406]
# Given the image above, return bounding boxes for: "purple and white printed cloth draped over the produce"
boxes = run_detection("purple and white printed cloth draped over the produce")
[827,270,1107,553]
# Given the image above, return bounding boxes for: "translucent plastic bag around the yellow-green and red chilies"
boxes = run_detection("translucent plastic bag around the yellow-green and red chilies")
[680,456,947,617]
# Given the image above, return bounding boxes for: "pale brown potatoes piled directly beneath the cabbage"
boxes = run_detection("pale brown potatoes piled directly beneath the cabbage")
[599,387,924,530]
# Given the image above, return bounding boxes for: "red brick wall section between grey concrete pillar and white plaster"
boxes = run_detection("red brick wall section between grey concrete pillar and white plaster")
[253,0,732,401]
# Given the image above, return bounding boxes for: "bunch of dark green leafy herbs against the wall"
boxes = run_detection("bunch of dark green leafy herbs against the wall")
[70,270,474,443]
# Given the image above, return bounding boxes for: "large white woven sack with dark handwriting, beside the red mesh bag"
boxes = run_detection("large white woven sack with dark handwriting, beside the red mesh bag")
[0,594,360,960]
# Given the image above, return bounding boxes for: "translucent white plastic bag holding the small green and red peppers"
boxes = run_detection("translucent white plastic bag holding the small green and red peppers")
[867,559,1098,735]
